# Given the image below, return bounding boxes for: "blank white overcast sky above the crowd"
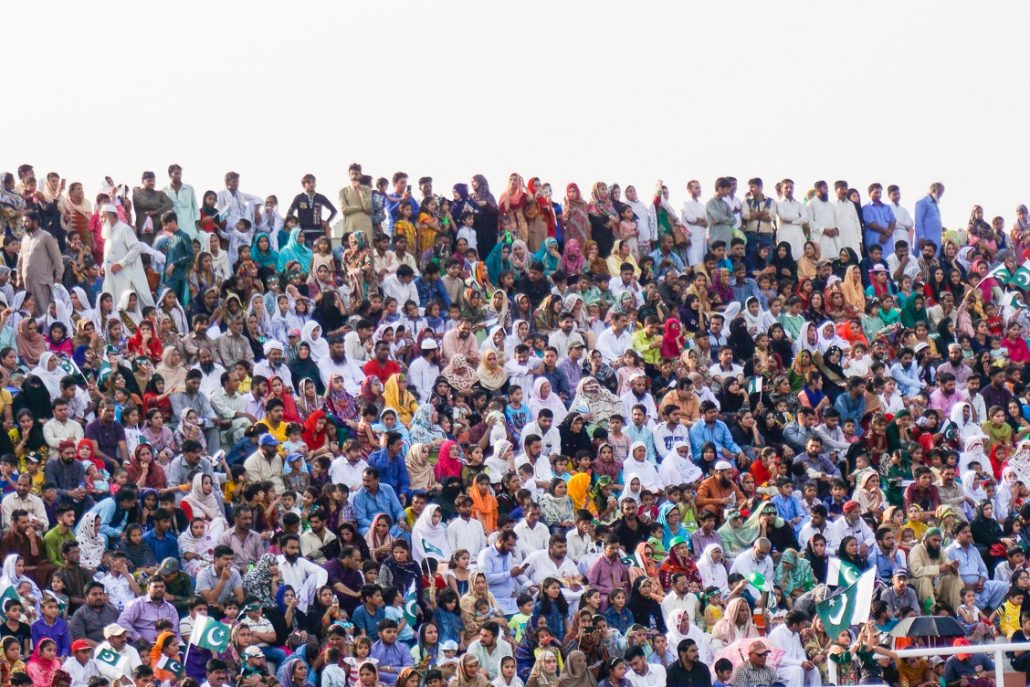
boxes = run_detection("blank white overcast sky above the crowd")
[10,0,1030,226]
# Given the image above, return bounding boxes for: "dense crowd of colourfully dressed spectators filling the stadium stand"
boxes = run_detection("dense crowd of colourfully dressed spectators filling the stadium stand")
[0,164,1030,687]
